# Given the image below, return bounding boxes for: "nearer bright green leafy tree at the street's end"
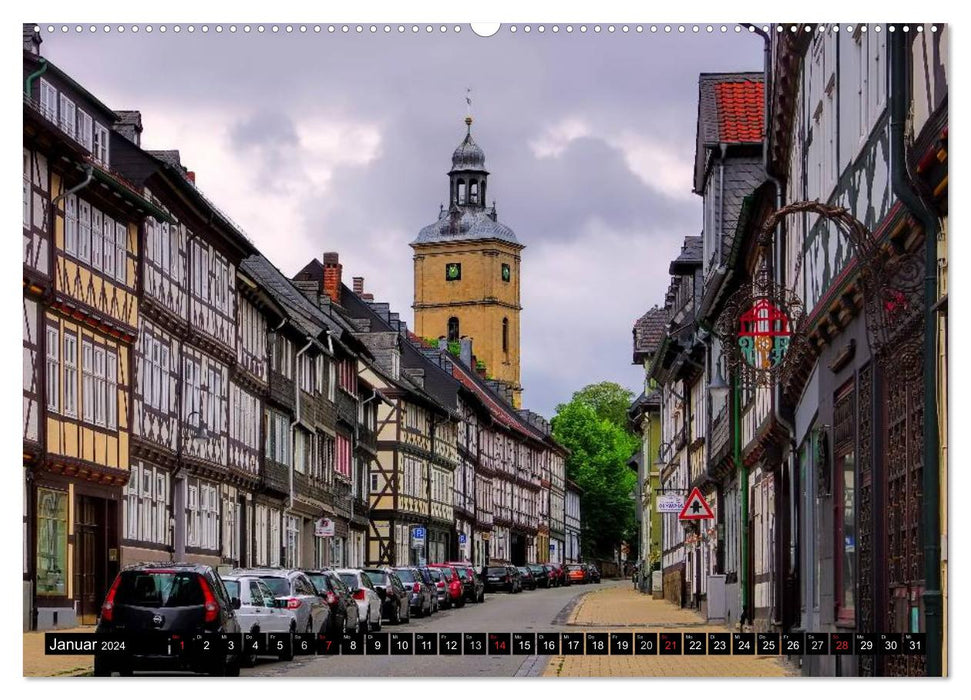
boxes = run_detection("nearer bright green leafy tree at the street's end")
[552,396,638,557]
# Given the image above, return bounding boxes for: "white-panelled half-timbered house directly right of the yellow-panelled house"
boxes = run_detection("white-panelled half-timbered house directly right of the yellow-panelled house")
[111,127,267,566]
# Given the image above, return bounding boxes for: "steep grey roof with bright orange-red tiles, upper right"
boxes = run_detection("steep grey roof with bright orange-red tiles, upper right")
[694,72,765,192]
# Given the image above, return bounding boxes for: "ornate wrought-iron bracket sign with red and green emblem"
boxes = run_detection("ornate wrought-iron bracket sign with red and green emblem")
[715,201,924,386]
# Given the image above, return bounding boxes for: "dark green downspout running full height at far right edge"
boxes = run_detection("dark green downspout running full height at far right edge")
[890,26,942,676]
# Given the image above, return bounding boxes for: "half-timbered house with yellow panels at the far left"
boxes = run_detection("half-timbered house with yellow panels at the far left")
[23,37,167,629]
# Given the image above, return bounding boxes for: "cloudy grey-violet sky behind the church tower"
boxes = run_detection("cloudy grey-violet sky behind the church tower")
[41,25,762,415]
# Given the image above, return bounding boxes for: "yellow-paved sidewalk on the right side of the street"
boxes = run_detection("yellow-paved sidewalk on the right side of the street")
[542,585,796,678]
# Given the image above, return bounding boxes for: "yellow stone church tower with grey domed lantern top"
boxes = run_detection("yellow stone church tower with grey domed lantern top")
[411,117,525,408]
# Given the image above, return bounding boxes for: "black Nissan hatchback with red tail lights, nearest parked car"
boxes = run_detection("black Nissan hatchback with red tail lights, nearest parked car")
[94,562,242,676]
